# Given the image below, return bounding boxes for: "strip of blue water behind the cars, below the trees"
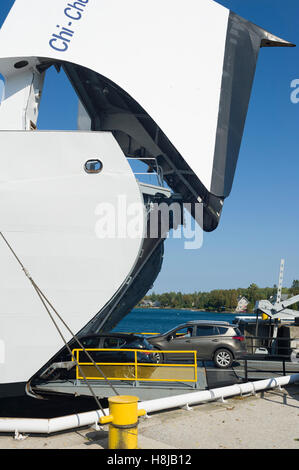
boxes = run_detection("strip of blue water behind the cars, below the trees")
[114,308,253,333]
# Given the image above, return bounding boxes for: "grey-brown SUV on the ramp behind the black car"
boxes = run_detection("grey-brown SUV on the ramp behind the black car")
[148,320,247,369]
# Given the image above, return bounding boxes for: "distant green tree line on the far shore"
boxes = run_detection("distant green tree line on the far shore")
[139,280,299,312]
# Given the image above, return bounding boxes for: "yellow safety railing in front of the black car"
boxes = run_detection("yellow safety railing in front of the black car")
[73,348,197,383]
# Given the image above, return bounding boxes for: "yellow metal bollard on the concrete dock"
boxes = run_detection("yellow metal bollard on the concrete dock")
[100,395,146,449]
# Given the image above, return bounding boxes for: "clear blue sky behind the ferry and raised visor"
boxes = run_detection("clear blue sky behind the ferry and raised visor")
[0,0,299,292]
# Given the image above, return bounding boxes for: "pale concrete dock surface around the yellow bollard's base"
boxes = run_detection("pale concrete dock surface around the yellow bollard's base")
[0,384,299,450]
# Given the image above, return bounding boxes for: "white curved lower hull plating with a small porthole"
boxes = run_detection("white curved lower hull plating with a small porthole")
[0,131,146,383]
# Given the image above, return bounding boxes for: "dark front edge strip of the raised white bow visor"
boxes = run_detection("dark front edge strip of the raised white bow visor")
[210,12,294,198]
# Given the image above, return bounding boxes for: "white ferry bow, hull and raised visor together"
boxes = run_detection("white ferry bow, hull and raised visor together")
[0,0,292,395]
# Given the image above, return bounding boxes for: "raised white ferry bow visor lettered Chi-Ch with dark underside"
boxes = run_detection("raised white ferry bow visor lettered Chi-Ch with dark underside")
[0,0,292,231]
